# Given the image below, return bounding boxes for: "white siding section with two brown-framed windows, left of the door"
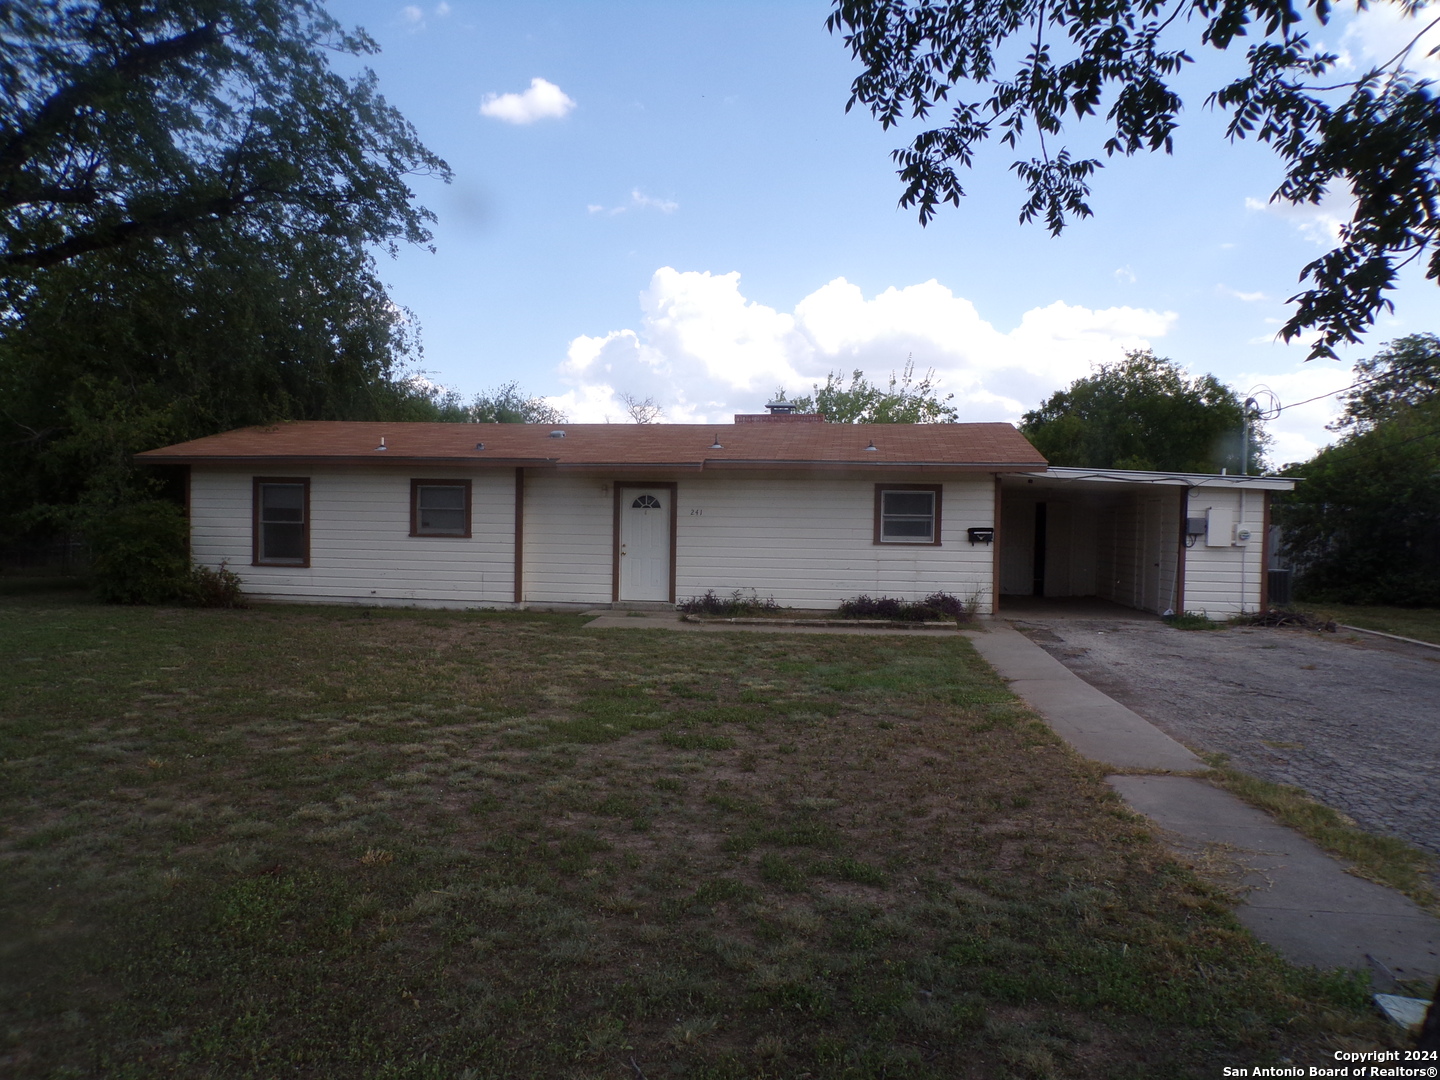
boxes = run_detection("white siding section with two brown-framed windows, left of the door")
[182,467,514,606]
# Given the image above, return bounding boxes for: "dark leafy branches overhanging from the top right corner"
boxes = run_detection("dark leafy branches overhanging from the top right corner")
[827,0,1440,357]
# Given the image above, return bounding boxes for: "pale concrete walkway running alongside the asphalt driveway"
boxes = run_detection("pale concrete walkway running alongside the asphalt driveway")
[968,622,1440,989]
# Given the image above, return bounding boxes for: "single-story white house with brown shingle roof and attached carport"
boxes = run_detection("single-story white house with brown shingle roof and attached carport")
[138,409,1292,615]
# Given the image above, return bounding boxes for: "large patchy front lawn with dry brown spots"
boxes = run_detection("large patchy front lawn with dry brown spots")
[0,593,1395,1080]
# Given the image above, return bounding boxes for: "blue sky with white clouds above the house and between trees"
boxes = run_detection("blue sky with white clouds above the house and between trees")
[345,0,1440,461]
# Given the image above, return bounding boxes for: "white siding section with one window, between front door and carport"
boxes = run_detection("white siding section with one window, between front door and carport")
[675,474,995,612]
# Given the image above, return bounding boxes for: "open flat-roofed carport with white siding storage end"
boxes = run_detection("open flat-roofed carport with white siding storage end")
[995,468,1295,618]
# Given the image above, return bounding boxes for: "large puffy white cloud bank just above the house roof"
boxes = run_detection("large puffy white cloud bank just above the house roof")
[550,266,1175,422]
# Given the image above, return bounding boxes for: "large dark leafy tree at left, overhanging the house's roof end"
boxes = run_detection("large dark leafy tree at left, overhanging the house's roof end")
[0,0,448,530]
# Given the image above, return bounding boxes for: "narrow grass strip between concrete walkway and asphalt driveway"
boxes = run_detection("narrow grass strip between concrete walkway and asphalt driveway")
[1205,743,1440,914]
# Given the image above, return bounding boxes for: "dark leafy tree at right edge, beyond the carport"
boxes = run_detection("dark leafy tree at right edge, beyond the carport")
[1276,334,1440,606]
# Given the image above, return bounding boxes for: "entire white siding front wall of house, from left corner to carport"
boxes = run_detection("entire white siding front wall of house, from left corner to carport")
[190,467,995,612]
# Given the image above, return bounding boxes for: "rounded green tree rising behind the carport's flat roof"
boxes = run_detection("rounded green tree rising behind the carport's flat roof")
[1020,350,1263,472]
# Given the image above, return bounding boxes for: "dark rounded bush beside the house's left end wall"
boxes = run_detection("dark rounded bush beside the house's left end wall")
[85,500,192,603]
